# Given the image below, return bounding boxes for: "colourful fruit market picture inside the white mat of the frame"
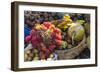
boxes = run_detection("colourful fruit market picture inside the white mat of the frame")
[24,11,90,62]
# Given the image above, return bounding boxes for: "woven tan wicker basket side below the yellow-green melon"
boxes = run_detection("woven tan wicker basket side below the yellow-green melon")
[55,37,87,60]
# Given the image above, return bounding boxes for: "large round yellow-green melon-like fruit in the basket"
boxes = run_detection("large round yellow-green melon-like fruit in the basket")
[68,23,85,41]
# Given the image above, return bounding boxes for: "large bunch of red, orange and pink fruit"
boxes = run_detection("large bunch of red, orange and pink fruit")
[25,22,62,60]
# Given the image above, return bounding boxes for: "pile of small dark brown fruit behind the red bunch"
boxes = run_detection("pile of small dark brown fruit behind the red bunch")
[24,11,63,27]
